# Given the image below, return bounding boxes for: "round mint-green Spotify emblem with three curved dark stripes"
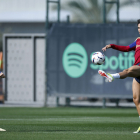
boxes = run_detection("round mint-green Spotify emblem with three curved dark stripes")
[62,43,88,78]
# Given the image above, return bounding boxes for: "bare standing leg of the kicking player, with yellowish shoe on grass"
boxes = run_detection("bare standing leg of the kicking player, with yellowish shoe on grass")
[132,78,140,133]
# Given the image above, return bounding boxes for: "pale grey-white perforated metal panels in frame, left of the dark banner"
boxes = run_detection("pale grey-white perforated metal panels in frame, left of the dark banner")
[3,34,46,105]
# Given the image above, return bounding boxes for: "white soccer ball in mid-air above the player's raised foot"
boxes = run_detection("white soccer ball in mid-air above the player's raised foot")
[92,52,105,65]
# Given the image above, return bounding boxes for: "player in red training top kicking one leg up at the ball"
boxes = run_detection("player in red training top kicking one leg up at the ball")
[98,19,140,133]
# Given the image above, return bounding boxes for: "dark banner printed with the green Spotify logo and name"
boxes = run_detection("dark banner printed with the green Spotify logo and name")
[47,24,138,98]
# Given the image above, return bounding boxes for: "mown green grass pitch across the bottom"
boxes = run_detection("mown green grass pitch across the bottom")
[0,107,140,140]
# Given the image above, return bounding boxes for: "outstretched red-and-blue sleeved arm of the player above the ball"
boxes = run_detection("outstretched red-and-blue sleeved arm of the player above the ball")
[102,41,136,52]
